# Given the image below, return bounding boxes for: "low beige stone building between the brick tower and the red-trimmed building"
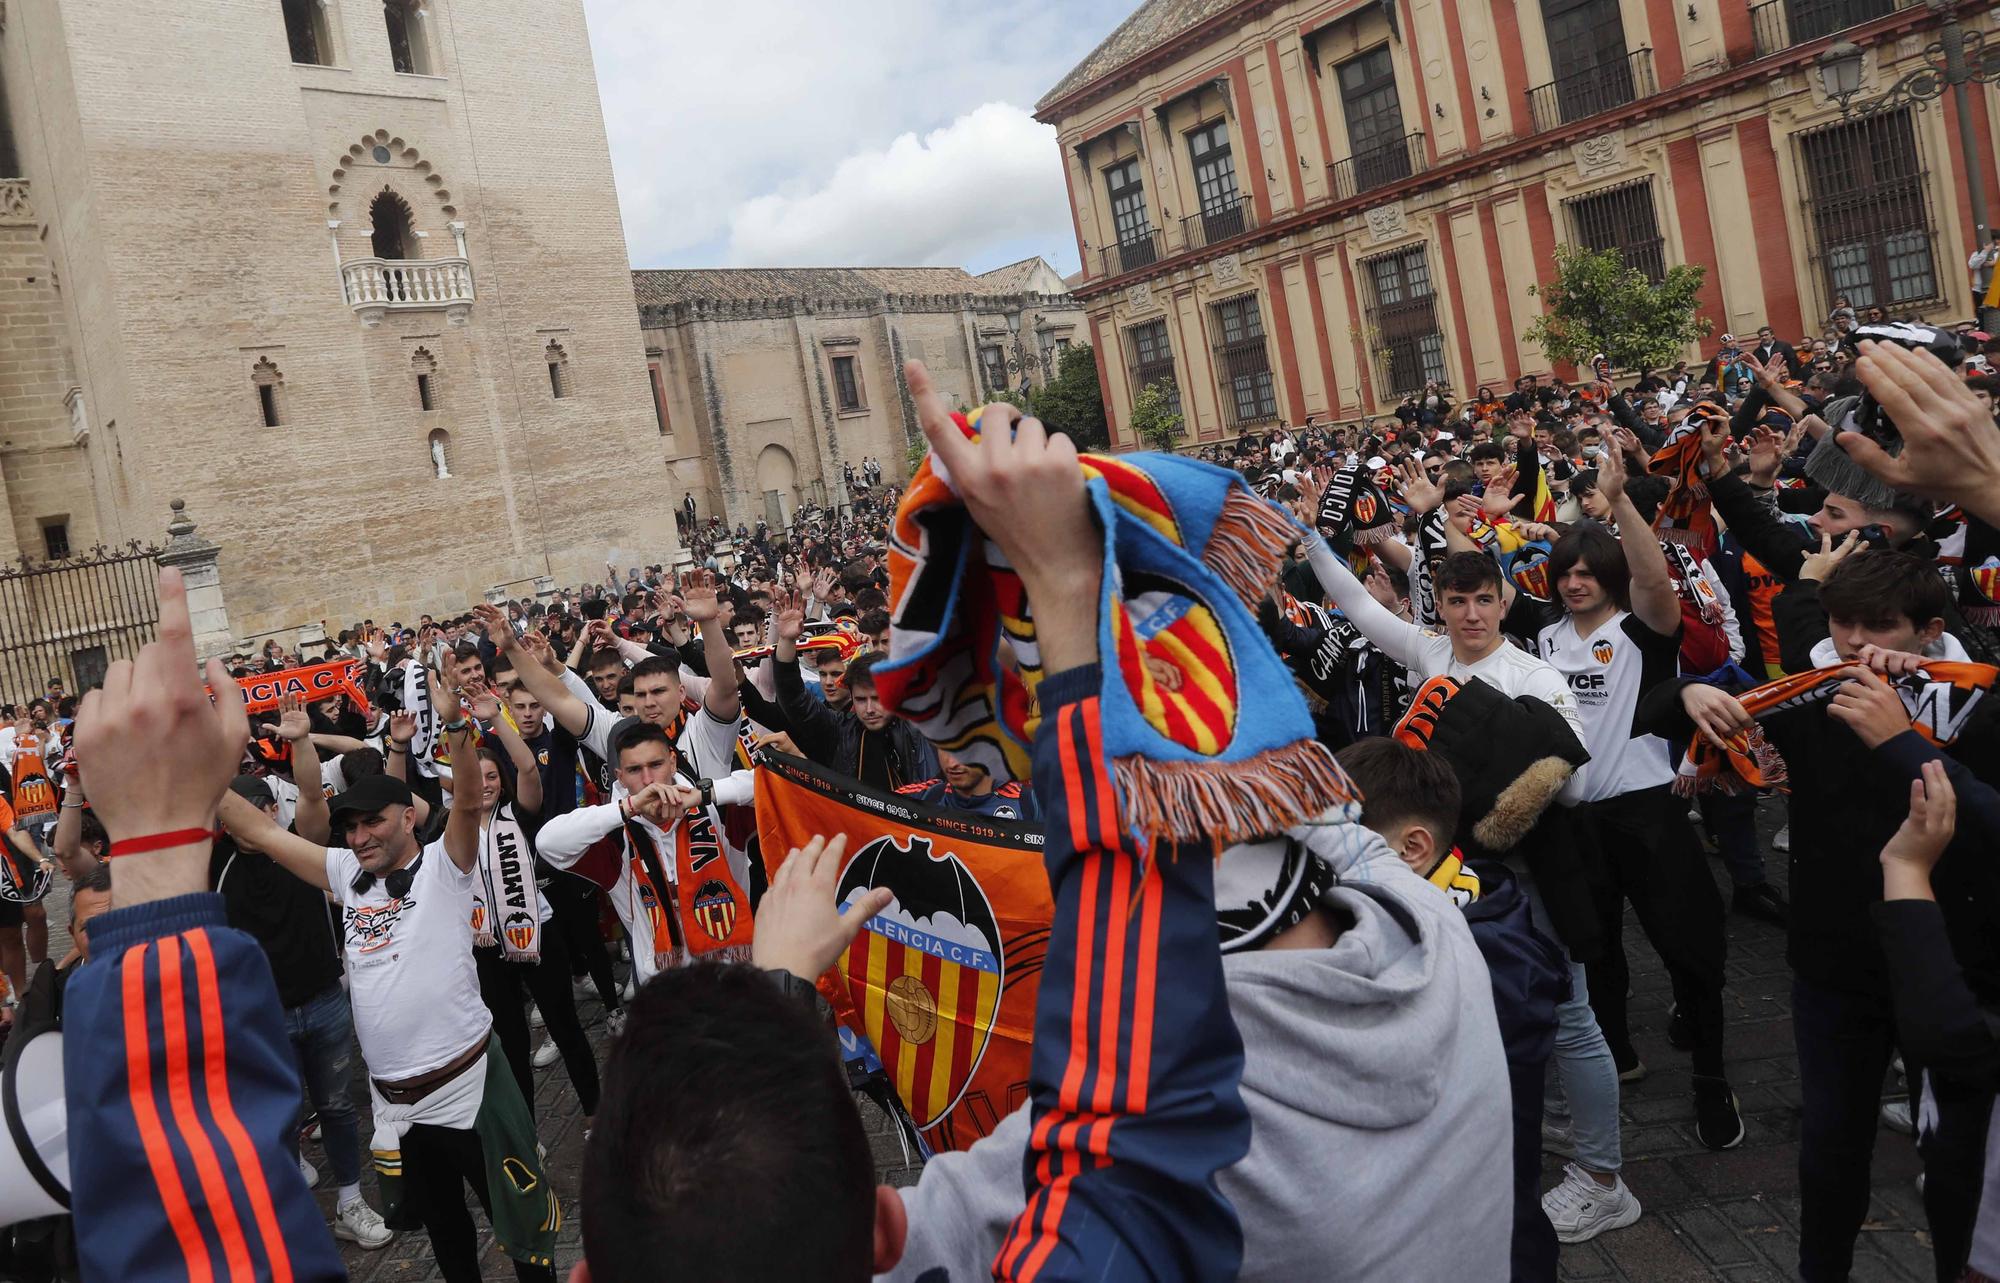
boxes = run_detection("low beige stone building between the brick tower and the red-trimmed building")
[632,258,1082,528]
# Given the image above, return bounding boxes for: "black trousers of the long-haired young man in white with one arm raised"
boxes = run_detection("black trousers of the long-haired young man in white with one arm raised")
[1576,785,1726,1077]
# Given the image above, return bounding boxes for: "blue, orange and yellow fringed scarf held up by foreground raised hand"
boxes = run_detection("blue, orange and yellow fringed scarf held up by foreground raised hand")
[874,418,1360,849]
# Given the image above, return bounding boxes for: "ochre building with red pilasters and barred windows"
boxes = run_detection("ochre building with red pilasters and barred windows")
[1036,0,2000,446]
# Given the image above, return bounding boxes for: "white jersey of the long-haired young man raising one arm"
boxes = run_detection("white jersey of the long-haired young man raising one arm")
[1536,610,1680,801]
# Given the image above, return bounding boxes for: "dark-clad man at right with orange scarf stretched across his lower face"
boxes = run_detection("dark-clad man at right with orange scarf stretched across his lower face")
[1640,550,2000,1283]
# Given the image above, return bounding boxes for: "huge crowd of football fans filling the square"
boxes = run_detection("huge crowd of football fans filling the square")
[0,310,2000,1283]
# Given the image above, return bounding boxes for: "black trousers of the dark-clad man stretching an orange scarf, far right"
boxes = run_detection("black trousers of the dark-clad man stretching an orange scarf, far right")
[1792,977,1992,1283]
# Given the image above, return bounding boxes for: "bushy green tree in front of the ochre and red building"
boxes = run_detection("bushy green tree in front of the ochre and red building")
[1526,246,1714,370]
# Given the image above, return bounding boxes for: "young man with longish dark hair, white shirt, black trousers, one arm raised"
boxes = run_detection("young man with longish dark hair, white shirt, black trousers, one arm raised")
[1536,443,1744,1149]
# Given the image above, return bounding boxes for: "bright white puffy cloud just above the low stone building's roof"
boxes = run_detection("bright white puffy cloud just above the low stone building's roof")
[730,102,1074,268]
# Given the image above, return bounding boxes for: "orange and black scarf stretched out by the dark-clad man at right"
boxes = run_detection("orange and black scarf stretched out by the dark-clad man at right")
[1674,659,2000,795]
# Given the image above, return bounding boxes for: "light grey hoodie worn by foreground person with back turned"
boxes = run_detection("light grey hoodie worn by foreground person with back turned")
[880,833,1514,1283]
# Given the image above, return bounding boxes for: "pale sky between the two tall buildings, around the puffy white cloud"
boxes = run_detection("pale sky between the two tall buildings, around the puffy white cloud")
[584,0,1134,270]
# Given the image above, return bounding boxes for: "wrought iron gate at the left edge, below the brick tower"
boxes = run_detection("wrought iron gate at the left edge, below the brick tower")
[0,540,160,703]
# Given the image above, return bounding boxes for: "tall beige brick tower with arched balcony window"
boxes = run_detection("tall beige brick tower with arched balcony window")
[0,0,678,638]
